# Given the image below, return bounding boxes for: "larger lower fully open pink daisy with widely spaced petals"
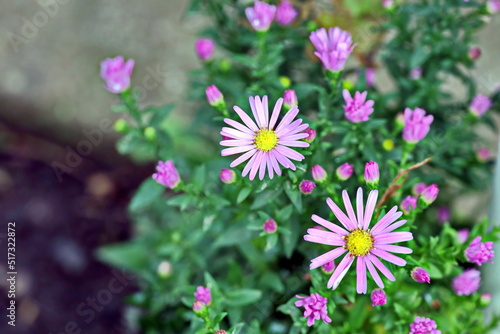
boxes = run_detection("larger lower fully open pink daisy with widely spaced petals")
[304,188,413,293]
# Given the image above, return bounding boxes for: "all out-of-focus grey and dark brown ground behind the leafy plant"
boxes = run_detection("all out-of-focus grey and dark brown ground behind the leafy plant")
[0,0,500,334]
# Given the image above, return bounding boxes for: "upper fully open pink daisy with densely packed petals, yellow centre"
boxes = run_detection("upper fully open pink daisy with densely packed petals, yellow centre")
[220,96,309,180]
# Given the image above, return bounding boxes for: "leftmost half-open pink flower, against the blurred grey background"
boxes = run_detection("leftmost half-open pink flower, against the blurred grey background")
[101,56,135,94]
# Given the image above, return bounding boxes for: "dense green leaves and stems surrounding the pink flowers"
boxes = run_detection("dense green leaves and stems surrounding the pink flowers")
[98,0,500,334]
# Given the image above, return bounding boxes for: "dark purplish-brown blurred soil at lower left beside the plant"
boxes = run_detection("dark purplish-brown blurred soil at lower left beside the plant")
[0,128,149,334]
